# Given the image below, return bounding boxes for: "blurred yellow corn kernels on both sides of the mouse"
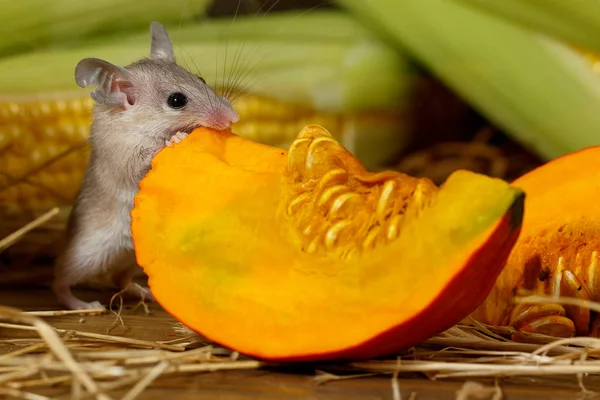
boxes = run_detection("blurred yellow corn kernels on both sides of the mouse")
[0,94,403,222]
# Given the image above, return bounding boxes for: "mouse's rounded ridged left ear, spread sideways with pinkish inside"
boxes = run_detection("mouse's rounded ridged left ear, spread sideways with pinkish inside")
[75,58,135,106]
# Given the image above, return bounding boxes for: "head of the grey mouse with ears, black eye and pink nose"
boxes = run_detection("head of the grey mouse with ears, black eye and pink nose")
[75,22,239,131]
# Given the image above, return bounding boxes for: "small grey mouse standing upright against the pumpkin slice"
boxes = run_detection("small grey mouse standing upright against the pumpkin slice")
[52,22,239,309]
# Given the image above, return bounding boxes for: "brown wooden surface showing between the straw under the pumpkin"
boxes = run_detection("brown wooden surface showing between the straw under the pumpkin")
[0,289,600,400]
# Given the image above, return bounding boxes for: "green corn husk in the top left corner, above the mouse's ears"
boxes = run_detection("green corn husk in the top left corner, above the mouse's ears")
[0,0,211,56]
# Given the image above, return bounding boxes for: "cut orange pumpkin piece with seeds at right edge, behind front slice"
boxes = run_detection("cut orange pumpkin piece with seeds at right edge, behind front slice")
[471,146,600,341]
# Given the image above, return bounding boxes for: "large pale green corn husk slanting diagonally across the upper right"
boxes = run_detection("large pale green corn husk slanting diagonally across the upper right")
[339,0,600,159]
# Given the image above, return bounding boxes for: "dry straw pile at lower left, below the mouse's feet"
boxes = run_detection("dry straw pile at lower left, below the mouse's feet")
[0,307,262,400]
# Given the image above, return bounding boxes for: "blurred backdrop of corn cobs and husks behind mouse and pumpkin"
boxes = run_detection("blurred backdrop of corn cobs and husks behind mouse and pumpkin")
[0,0,600,286]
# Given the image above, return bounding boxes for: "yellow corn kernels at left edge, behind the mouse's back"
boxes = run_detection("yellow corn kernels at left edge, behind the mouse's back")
[0,97,92,215]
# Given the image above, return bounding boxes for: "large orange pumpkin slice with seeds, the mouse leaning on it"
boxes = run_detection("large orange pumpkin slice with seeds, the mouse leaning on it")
[131,125,524,361]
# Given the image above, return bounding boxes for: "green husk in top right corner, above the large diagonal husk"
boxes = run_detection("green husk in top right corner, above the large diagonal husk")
[456,0,600,52]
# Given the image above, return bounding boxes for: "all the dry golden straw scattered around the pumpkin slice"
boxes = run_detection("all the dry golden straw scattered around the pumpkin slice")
[0,211,600,400]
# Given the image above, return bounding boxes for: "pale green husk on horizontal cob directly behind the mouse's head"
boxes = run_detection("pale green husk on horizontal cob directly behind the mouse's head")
[0,11,411,112]
